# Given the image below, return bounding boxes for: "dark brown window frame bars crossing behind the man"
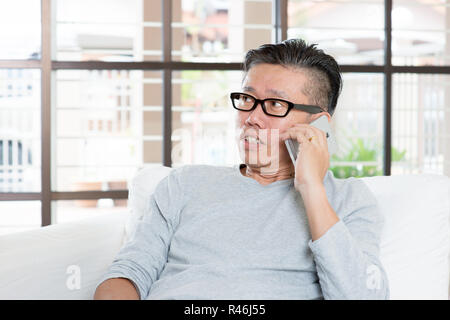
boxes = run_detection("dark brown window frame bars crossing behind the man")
[0,0,450,226]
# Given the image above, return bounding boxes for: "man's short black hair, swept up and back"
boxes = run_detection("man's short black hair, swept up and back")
[244,39,342,115]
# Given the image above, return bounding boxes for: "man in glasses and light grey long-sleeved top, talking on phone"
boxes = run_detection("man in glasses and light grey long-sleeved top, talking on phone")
[94,40,389,300]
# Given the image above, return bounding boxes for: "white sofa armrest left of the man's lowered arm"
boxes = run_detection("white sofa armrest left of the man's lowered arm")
[0,213,128,299]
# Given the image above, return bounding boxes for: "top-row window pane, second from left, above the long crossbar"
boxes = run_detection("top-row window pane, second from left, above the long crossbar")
[56,0,162,61]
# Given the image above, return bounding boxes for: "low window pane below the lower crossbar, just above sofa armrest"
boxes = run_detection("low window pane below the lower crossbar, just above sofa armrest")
[52,199,128,223]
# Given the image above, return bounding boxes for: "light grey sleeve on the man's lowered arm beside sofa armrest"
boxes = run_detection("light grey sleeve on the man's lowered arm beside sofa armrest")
[98,170,184,299]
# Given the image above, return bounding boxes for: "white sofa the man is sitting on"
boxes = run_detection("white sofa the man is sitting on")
[0,167,450,299]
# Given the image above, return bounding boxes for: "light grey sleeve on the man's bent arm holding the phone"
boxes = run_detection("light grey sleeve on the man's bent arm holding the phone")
[309,180,389,300]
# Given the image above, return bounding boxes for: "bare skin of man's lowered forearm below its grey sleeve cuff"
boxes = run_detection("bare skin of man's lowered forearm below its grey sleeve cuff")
[94,278,139,300]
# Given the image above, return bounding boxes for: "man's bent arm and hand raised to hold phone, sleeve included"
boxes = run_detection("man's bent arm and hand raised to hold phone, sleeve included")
[281,119,389,299]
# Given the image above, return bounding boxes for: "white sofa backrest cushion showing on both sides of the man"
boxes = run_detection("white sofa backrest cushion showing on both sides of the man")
[126,166,450,299]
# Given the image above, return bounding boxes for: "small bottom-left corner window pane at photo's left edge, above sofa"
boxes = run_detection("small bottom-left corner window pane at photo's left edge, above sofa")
[0,201,41,235]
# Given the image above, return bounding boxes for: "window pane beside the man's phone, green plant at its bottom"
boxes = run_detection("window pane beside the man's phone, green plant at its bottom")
[330,73,384,178]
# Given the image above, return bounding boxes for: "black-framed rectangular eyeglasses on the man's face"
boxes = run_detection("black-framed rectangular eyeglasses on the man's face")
[230,92,326,117]
